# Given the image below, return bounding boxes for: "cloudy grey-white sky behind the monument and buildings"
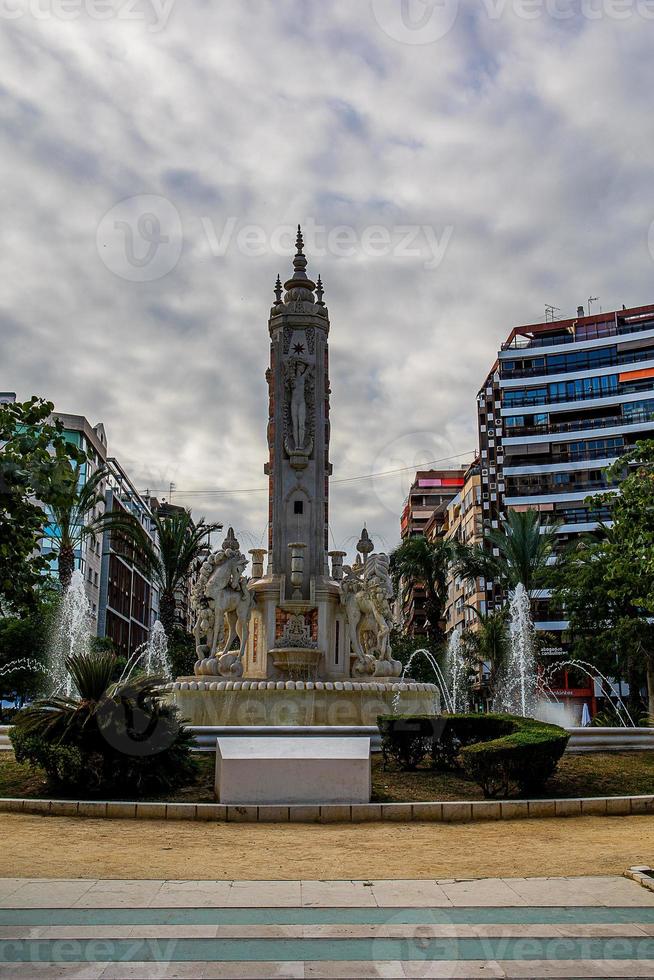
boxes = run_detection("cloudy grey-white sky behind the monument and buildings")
[0,0,654,547]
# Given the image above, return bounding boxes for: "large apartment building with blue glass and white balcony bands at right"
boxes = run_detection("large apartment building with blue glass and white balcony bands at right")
[477,298,654,647]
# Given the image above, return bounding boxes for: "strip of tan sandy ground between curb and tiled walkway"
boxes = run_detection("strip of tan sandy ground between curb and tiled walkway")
[0,814,654,880]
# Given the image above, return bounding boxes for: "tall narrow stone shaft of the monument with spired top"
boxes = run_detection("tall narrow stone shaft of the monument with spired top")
[264,225,332,599]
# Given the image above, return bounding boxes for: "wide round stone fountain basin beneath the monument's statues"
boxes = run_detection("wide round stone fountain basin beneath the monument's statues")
[166,677,440,726]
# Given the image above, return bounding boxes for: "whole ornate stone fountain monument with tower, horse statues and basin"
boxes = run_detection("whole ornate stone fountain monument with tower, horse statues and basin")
[181,226,437,725]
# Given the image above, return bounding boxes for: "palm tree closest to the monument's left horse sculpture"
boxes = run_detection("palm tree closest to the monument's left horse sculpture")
[140,508,222,639]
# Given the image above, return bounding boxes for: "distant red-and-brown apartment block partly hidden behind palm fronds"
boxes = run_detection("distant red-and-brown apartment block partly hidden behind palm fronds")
[400,469,465,634]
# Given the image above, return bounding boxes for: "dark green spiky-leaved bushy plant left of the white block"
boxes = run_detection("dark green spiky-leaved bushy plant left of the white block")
[10,651,196,795]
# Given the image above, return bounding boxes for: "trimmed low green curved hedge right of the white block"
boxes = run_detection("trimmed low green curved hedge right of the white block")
[378,714,569,798]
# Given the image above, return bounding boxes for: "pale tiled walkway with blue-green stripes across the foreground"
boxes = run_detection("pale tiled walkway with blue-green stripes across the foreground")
[0,877,654,980]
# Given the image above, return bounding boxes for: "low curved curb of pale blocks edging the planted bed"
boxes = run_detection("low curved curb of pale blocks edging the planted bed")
[0,796,654,823]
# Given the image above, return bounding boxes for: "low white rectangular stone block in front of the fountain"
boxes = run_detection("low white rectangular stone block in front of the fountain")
[215,736,371,806]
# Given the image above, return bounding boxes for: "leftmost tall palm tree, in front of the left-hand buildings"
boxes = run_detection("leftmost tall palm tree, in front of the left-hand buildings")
[45,463,142,589]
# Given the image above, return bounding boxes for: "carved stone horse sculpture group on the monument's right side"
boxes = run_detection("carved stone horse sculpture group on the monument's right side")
[341,554,402,677]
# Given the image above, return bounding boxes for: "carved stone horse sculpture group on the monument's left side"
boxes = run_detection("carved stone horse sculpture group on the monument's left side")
[193,527,254,677]
